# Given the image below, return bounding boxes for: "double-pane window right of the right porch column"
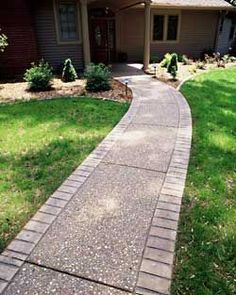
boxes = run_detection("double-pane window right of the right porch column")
[153,14,180,42]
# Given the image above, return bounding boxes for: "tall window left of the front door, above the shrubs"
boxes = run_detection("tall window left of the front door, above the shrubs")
[55,0,80,42]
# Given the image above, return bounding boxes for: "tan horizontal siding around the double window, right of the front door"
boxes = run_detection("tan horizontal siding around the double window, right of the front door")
[117,9,218,61]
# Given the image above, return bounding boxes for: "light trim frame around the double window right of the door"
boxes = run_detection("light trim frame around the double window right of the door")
[151,9,182,44]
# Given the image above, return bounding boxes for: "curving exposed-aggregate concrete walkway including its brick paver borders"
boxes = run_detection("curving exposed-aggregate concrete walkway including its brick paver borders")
[0,68,191,295]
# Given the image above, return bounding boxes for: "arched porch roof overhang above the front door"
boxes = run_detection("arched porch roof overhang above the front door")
[87,0,152,12]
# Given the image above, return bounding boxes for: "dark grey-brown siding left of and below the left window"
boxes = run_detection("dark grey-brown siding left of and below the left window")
[34,0,83,70]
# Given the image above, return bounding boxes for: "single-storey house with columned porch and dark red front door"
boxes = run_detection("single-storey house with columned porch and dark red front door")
[0,0,236,76]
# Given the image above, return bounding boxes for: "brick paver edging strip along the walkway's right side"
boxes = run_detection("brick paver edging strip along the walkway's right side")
[136,89,192,295]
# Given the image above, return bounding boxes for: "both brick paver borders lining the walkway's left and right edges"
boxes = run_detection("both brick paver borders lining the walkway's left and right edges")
[0,77,192,295]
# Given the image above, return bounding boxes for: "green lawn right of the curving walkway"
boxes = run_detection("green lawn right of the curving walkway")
[172,68,236,295]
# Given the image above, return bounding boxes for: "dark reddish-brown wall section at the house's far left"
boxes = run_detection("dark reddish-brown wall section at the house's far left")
[0,0,37,78]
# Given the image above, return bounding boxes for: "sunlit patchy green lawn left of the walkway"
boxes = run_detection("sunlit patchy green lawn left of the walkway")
[0,97,128,252]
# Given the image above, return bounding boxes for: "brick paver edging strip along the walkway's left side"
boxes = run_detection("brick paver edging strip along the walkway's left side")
[0,91,140,294]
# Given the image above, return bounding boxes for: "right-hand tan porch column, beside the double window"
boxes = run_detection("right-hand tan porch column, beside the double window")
[143,1,151,70]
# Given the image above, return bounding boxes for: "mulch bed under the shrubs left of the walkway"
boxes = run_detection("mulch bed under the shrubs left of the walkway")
[0,78,132,103]
